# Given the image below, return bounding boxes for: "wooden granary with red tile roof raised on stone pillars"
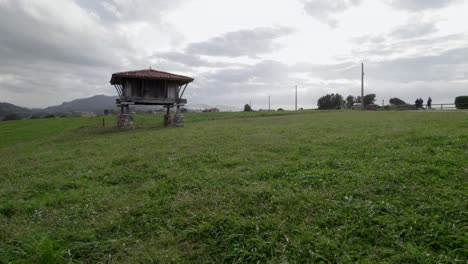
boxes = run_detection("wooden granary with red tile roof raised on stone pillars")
[110,68,194,128]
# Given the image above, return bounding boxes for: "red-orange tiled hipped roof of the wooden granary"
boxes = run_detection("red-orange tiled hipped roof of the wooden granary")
[110,68,194,84]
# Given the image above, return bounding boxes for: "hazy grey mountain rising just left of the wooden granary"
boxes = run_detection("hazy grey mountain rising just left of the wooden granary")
[42,95,118,114]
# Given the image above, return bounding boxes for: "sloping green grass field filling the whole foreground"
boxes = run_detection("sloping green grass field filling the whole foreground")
[0,111,468,263]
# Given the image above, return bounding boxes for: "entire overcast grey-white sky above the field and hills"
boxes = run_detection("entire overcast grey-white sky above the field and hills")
[0,0,468,109]
